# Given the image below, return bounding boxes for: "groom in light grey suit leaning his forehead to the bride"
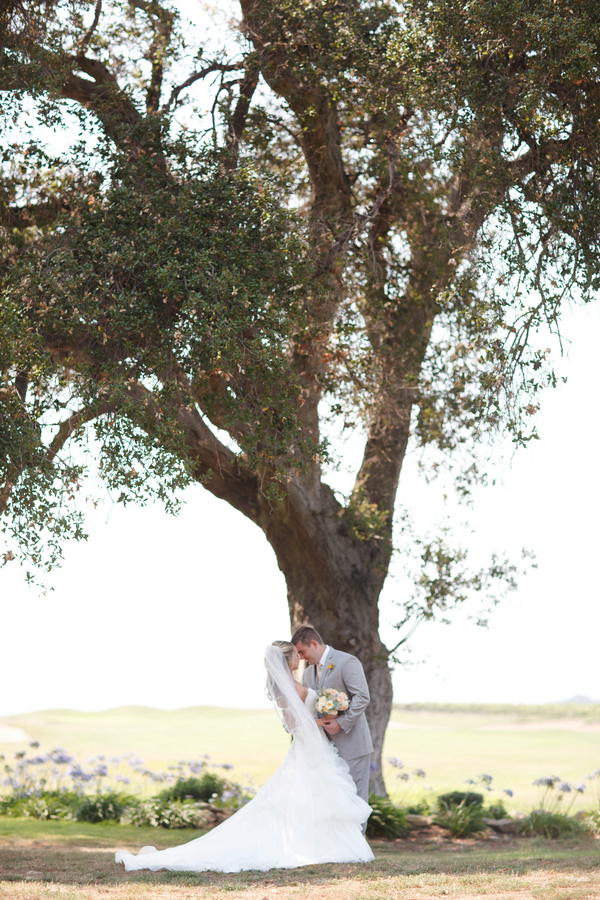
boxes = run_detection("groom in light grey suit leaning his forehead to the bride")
[292,625,373,802]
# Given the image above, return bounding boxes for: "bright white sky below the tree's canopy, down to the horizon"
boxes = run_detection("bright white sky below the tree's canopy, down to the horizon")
[0,298,600,715]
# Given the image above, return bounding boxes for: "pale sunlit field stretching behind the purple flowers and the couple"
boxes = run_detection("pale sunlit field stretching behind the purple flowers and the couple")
[0,706,600,810]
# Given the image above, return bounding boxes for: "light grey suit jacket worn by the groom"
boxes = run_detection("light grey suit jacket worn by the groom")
[302,647,373,760]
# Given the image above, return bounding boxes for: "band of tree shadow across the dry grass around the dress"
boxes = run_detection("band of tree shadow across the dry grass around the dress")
[0,839,600,891]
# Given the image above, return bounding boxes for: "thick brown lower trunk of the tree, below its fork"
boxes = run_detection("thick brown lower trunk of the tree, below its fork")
[260,479,392,796]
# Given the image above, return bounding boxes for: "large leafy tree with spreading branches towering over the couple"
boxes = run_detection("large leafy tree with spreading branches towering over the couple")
[0,0,600,790]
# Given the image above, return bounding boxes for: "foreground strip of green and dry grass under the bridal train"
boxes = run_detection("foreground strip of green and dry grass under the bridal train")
[0,819,600,900]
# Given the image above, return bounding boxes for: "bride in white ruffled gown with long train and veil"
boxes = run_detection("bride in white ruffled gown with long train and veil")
[115,641,374,872]
